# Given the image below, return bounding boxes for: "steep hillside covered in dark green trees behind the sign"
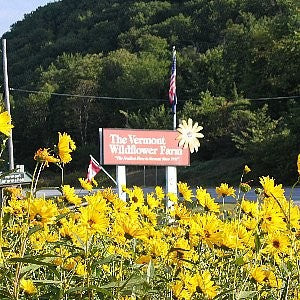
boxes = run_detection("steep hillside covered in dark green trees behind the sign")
[1,0,300,183]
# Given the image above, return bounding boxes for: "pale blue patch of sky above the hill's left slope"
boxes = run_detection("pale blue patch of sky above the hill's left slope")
[0,0,58,37]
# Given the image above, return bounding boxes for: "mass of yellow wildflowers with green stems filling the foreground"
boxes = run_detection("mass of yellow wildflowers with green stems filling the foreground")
[0,112,300,300]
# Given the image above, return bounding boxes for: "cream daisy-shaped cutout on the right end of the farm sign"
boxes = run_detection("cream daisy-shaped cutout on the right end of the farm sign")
[176,118,204,153]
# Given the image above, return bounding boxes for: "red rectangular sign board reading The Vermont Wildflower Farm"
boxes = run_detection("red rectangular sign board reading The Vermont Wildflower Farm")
[100,128,190,166]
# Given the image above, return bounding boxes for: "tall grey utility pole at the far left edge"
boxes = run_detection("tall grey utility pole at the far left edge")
[2,39,15,170]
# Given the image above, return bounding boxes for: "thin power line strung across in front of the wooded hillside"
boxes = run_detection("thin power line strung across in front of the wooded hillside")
[10,88,300,102]
